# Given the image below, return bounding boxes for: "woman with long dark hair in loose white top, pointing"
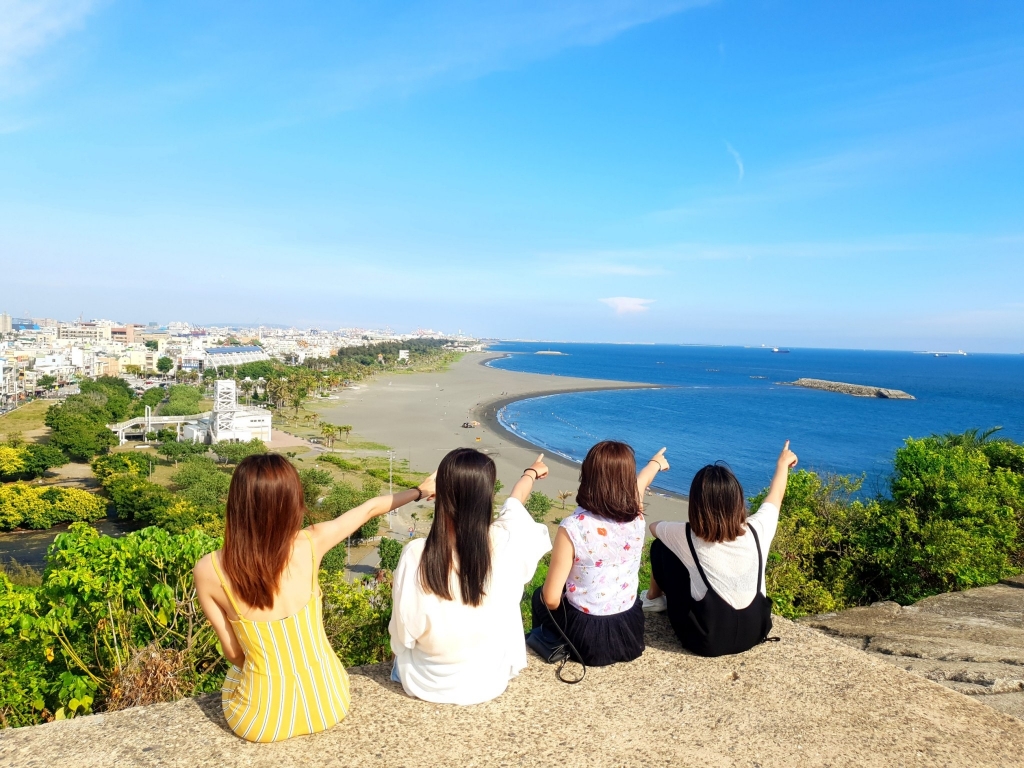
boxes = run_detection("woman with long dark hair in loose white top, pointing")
[390,449,551,705]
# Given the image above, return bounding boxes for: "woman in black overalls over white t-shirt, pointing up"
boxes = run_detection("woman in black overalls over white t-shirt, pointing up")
[641,440,797,656]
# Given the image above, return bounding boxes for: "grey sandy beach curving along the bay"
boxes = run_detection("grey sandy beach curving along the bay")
[319,352,686,521]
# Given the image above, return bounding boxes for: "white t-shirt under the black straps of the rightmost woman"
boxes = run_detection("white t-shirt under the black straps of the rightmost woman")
[655,503,778,610]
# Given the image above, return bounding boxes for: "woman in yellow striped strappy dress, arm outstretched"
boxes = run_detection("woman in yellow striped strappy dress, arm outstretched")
[194,454,433,741]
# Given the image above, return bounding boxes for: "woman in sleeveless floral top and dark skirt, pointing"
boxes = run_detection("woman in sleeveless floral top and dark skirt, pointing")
[532,440,669,667]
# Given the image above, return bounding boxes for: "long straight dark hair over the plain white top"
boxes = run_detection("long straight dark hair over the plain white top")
[420,449,497,606]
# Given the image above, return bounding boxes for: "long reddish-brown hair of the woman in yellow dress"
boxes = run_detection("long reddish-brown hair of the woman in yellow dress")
[221,454,306,608]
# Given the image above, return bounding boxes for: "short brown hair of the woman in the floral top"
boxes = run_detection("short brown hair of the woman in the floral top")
[577,440,643,522]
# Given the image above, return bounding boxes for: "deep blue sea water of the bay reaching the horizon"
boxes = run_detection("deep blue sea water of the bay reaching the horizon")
[489,343,1024,495]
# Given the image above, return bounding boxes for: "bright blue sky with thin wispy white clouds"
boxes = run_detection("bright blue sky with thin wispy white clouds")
[0,0,1024,353]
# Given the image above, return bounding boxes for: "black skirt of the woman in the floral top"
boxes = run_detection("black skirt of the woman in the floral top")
[532,587,644,667]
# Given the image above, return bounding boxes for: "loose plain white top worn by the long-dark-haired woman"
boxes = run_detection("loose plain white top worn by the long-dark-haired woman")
[388,499,551,705]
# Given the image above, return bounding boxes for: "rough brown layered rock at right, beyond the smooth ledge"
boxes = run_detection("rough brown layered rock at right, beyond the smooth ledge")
[802,577,1024,724]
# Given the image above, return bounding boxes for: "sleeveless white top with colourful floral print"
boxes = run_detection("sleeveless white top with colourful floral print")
[560,508,645,615]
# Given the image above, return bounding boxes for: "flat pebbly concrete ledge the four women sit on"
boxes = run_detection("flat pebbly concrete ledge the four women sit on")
[0,614,1024,768]
